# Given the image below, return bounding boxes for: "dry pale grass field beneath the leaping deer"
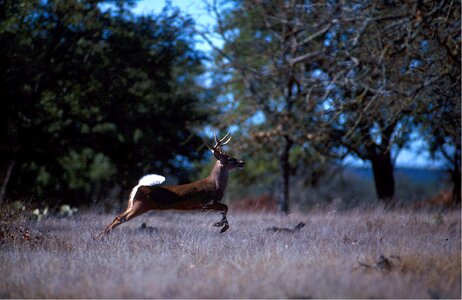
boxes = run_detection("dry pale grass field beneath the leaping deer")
[0,210,461,298]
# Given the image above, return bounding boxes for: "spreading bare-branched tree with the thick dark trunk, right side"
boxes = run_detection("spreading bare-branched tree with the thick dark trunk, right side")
[324,1,460,204]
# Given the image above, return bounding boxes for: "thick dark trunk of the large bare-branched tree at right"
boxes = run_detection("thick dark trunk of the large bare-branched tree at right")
[370,152,395,204]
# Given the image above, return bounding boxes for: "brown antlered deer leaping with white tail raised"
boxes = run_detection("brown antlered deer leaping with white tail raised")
[97,133,245,237]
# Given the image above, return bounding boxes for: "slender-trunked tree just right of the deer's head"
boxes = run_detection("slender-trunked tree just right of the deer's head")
[207,1,340,213]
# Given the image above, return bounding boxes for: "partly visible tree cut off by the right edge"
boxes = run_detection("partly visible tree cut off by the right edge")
[416,1,461,205]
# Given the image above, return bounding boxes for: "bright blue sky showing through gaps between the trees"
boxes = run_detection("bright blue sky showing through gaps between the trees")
[133,0,444,168]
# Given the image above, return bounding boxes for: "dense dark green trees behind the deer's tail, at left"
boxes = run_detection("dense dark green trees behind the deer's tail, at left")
[0,0,207,204]
